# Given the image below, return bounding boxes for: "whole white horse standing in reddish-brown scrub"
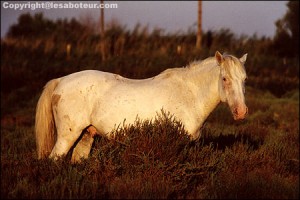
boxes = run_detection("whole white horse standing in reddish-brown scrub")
[35,51,248,162]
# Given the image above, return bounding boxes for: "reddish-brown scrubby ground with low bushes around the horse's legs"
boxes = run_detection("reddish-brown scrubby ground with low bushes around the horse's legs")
[1,88,299,199]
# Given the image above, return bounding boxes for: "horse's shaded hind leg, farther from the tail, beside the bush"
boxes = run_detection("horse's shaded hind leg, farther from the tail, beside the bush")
[71,132,94,163]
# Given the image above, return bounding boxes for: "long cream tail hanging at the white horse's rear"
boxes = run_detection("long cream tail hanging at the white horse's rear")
[35,79,60,159]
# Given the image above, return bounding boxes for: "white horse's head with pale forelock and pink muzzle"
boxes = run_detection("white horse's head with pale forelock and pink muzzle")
[215,51,248,120]
